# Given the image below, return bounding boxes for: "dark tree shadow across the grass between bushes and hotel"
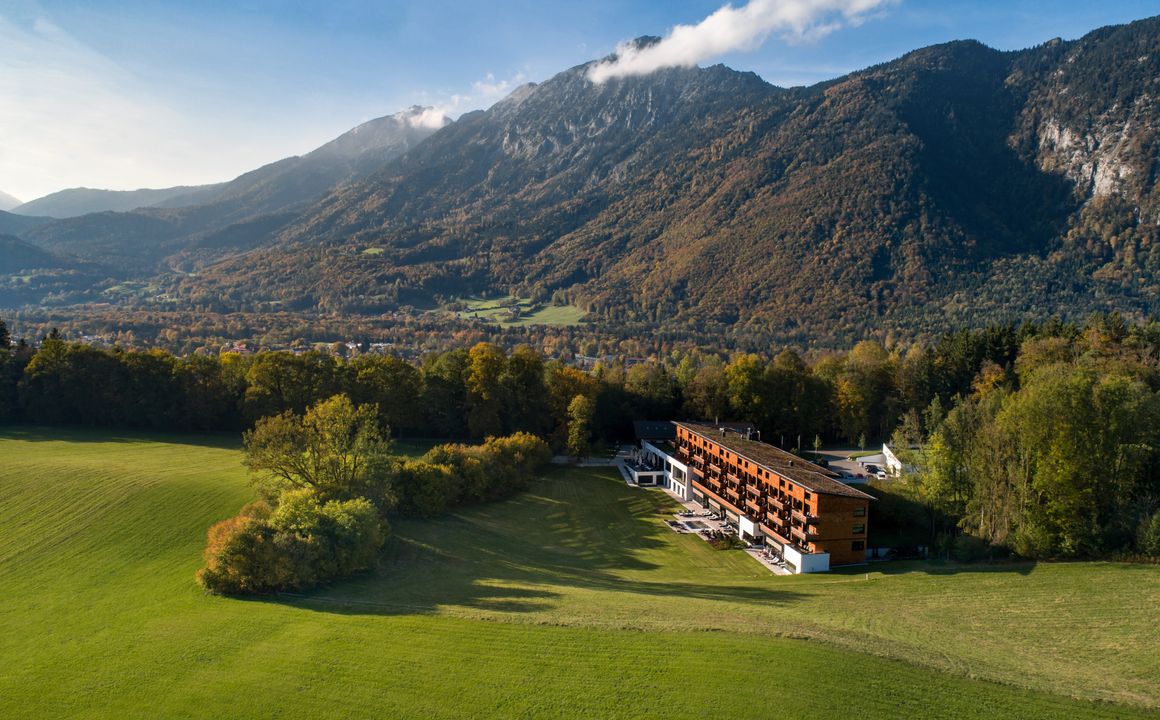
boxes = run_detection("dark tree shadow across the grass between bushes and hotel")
[266,471,804,614]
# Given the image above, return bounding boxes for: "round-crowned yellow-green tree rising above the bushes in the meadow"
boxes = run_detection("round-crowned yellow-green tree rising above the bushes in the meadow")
[242,395,392,505]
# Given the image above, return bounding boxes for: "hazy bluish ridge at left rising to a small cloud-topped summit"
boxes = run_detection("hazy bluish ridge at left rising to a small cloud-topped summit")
[18,107,449,272]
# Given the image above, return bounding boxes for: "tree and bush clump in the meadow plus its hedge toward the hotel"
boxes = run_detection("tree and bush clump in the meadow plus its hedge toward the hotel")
[197,395,551,595]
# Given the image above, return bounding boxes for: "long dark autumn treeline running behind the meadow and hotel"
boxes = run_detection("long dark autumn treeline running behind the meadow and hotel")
[0,315,1160,454]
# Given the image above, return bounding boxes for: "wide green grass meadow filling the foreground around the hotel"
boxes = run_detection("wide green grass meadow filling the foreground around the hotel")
[0,429,1160,718]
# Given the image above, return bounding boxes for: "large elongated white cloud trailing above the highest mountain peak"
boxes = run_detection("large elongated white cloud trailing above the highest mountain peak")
[588,0,898,83]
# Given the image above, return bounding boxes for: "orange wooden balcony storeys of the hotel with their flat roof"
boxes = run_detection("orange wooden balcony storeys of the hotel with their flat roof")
[676,423,871,566]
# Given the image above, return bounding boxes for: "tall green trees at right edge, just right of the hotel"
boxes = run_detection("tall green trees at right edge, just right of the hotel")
[897,317,1160,559]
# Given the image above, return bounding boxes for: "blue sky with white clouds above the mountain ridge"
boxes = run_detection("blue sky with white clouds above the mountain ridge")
[0,0,1160,201]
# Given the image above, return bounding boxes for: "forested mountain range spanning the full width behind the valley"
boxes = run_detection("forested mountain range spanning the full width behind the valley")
[0,19,1160,341]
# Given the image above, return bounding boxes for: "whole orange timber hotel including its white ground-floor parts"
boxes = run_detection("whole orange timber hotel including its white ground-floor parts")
[641,422,873,573]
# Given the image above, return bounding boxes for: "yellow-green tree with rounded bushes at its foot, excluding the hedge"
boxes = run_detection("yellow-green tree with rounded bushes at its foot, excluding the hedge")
[197,395,393,595]
